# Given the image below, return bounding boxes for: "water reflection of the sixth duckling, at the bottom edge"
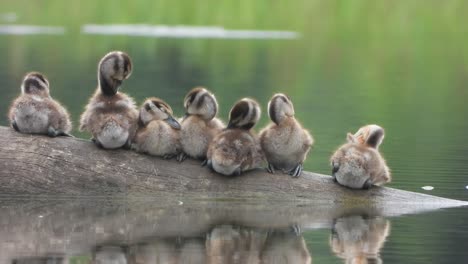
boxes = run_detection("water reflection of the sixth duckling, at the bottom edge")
[261,228,312,264]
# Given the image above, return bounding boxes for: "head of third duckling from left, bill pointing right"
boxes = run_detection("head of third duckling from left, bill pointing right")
[140,97,180,129]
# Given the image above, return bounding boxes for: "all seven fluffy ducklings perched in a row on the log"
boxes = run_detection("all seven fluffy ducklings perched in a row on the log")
[9,51,391,189]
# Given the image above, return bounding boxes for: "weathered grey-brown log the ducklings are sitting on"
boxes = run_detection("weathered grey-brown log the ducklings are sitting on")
[0,127,467,207]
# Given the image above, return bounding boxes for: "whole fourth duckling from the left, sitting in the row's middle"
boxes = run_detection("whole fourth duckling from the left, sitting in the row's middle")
[177,87,224,163]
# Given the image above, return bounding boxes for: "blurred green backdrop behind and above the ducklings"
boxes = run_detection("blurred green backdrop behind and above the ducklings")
[0,0,468,200]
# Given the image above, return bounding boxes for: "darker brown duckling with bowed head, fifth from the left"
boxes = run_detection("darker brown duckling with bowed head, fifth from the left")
[207,98,264,175]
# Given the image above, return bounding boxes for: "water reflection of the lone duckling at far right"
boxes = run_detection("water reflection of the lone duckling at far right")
[330,215,390,263]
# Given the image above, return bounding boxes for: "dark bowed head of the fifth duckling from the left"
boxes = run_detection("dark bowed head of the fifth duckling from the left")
[227,98,261,130]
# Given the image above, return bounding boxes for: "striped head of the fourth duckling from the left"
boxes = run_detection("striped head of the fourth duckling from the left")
[184,87,218,120]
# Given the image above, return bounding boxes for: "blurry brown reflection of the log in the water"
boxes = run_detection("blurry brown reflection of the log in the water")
[0,197,454,264]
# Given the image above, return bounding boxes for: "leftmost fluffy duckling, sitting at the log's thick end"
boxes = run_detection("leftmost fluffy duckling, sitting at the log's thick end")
[8,72,72,137]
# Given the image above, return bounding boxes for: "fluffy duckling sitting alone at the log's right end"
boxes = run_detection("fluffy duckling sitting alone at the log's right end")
[331,125,391,189]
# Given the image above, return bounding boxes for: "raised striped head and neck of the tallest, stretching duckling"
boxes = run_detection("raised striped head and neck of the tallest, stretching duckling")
[98,51,132,95]
